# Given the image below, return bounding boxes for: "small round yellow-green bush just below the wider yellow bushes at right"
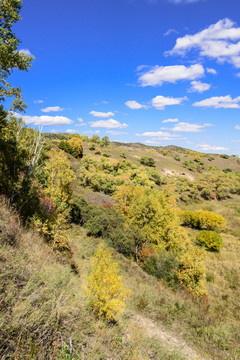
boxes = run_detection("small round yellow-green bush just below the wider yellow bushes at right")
[196,230,223,252]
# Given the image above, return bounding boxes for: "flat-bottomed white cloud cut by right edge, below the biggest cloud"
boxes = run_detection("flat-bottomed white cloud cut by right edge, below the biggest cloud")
[193,95,240,109]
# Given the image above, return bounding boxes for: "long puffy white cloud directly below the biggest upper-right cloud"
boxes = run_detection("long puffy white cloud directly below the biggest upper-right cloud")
[138,64,204,87]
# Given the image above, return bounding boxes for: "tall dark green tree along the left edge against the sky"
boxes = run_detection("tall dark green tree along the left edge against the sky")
[0,0,37,214]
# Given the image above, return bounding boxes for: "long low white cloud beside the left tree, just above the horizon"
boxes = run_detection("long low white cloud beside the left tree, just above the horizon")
[13,113,73,125]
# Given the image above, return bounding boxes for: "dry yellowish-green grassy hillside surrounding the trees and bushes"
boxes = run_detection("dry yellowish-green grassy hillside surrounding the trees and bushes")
[0,136,240,360]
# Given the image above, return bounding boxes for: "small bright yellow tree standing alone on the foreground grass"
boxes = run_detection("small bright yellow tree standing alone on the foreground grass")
[86,243,130,321]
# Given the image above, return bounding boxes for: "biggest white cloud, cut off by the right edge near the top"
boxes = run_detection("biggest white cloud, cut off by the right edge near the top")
[166,18,240,68]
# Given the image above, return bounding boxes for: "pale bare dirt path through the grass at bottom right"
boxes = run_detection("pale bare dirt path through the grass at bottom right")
[133,315,210,360]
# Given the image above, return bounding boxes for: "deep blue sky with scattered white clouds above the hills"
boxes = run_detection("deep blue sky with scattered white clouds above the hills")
[12,0,240,155]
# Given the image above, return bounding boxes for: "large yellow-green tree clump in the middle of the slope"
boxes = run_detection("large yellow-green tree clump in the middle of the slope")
[115,185,205,296]
